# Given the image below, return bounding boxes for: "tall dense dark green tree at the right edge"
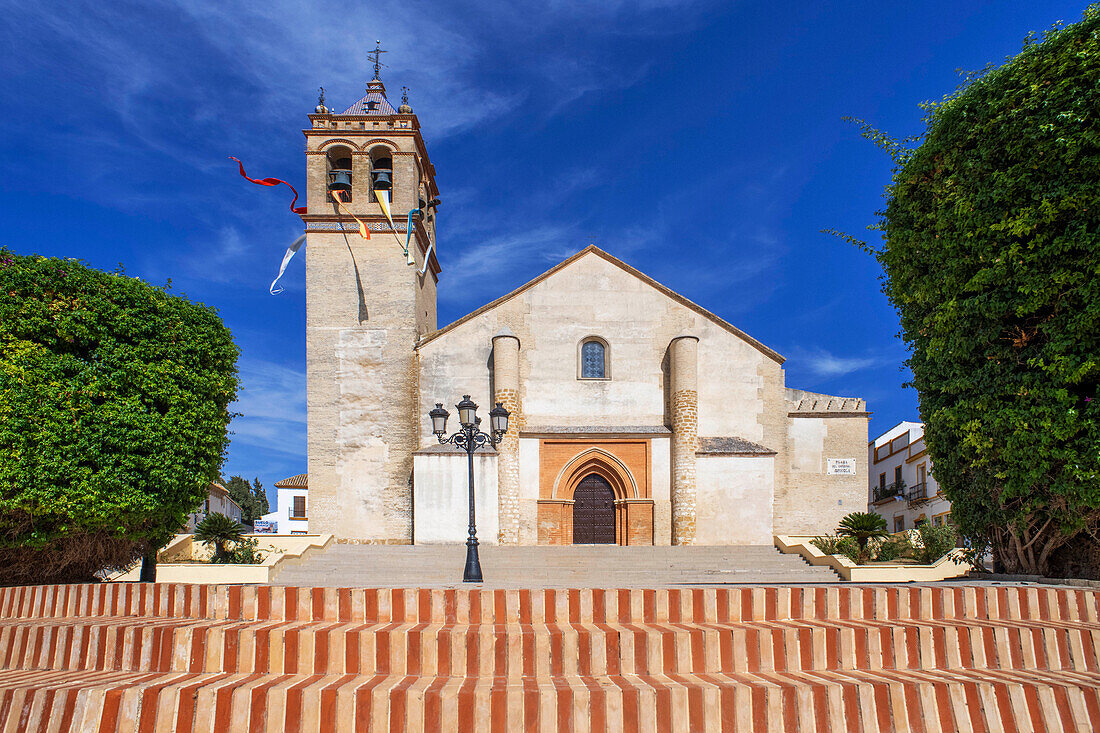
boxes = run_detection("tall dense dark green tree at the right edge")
[865,6,1100,572]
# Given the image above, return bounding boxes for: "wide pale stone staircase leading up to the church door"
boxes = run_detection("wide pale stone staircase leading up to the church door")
[274,545,840,589]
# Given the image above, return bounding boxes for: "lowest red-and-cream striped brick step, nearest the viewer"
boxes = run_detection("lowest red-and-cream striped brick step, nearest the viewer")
[0,670,1100,733]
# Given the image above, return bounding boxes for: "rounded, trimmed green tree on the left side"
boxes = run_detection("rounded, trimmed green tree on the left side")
[0,250,238,583]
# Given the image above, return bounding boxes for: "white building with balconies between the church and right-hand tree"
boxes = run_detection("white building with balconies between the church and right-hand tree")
[867,422,952,532]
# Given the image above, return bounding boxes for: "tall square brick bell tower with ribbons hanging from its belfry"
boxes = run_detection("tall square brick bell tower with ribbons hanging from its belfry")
[303,46,440,544]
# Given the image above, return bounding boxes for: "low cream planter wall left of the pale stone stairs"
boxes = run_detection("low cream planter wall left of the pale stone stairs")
[109,534,333,586]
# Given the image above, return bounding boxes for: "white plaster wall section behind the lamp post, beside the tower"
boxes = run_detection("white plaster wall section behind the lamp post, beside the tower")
[413,451,499,545]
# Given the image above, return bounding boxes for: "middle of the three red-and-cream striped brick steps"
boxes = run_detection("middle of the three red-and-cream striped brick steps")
[0,617,1100,677]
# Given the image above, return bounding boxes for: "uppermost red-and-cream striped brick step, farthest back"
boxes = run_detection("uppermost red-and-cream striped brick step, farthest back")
[0,583,1100,624]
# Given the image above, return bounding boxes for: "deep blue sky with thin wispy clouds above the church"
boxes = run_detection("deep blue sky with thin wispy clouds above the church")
[0,0,1085,497]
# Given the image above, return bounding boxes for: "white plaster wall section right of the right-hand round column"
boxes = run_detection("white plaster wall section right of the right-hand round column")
[695,456,776,545]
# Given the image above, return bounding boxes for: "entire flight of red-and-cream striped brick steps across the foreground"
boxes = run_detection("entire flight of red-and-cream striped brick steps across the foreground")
[0,583,1100,733]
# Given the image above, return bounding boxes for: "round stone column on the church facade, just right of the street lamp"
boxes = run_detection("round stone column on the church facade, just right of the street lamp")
[493,329,523,545]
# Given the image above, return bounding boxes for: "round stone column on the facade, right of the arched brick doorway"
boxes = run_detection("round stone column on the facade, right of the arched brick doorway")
[669,336,699,545]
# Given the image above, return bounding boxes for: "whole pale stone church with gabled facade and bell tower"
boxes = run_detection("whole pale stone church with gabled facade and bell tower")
[294,65,869,545]
